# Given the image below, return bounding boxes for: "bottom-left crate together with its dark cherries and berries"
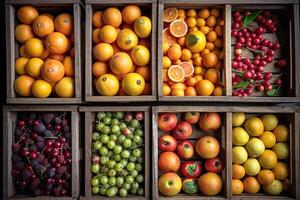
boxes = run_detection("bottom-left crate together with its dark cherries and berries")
[3,106,79,199]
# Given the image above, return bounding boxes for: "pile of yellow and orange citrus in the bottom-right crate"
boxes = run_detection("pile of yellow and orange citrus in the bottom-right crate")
[232,112,290,195]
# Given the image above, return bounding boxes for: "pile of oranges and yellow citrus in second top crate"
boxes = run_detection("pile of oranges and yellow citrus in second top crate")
[92,5,152,96]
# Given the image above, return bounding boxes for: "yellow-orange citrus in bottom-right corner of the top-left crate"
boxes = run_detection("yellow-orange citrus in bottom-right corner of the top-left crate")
[55,77,75,98]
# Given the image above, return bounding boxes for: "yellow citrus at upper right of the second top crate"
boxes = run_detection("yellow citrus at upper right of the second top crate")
[134,16,152,38]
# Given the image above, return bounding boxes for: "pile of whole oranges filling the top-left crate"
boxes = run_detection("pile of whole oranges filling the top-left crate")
[14,6,75,98]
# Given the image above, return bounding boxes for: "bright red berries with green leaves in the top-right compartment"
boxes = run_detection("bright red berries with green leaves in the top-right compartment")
[231,10,288,97]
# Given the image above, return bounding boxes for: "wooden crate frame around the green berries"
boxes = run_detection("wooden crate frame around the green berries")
[79,106,151,200]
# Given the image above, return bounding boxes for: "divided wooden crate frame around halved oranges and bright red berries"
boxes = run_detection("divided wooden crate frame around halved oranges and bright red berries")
[157,0,300,103]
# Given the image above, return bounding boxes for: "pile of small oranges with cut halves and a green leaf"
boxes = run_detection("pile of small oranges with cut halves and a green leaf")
[162,8,224,96]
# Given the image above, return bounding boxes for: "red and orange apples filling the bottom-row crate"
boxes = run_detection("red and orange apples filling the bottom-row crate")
[157,112,224,197]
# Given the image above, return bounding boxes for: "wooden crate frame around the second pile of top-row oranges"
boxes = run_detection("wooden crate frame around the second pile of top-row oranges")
[85,0,157,102]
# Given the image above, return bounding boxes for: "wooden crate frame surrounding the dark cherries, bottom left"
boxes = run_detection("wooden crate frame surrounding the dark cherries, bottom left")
[3,106,80,200]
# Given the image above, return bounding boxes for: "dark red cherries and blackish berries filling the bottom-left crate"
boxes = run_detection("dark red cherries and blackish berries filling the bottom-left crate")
[10,112,72,196]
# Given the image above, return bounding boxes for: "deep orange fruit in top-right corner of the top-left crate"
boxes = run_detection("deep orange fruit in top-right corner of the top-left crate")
[54,13,74,36]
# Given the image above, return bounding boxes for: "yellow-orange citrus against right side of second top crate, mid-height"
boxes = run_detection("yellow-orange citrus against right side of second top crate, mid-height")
[130,45,150,66]
